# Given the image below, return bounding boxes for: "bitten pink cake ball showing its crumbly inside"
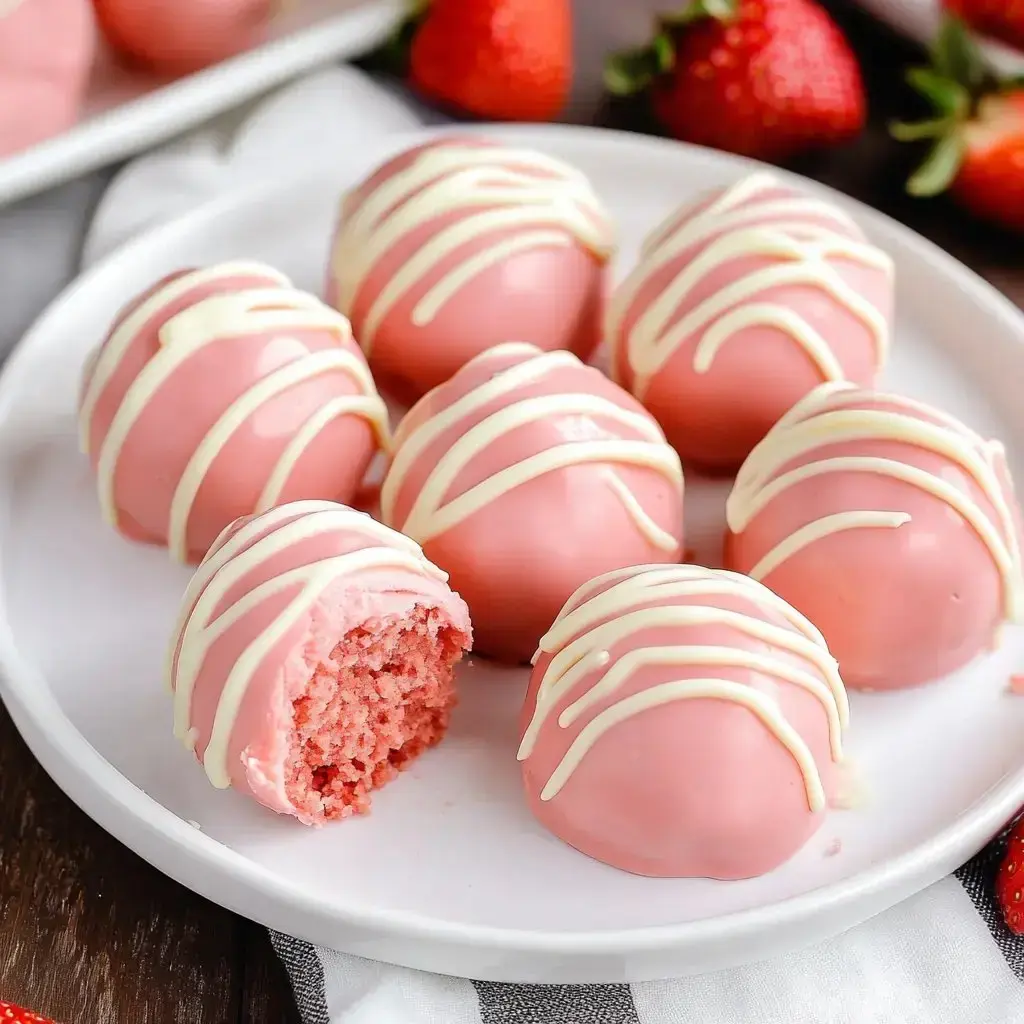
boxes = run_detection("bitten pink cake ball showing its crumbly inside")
[168,502,471,824]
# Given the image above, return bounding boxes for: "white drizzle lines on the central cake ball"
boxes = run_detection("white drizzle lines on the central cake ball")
[381,342,683,551]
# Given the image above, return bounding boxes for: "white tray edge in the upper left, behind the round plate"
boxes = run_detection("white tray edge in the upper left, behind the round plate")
[0,0,402,204]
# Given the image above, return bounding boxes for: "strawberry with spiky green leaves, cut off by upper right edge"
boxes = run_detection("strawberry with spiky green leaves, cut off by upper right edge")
[891,17,1024,231]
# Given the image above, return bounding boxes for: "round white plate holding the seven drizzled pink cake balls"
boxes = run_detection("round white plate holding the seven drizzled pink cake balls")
[0,128,1024,982]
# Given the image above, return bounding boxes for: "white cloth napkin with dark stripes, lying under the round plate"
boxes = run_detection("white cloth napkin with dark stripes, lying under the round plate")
[84,61,1024,1024]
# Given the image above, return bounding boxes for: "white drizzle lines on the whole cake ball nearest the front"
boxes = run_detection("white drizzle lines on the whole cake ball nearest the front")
[518,565,850,812]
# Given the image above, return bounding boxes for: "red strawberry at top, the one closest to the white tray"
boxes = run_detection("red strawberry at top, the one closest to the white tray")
[397,0,572,121]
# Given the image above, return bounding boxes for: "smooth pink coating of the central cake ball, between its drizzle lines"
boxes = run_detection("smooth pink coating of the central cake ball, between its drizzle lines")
[385,344,683,662]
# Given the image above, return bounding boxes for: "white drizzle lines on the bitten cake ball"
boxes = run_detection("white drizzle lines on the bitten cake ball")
[166,501,447,788]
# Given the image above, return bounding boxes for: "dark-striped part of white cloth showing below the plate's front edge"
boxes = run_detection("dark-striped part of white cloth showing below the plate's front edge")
[270,841,1024,1024]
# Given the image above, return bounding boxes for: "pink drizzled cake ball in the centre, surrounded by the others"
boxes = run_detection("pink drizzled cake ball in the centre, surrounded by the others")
[381,342,683,662]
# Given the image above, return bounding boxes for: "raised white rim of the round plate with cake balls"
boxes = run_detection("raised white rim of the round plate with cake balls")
[0,124,1024,980]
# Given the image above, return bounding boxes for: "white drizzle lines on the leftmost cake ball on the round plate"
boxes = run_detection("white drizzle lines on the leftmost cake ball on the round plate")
[79,263,390,561]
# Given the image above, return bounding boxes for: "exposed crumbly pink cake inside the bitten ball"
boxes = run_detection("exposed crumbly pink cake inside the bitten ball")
[286,605,467,822]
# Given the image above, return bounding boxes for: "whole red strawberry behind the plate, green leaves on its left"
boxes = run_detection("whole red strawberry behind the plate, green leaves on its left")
[605,0,864,160]
